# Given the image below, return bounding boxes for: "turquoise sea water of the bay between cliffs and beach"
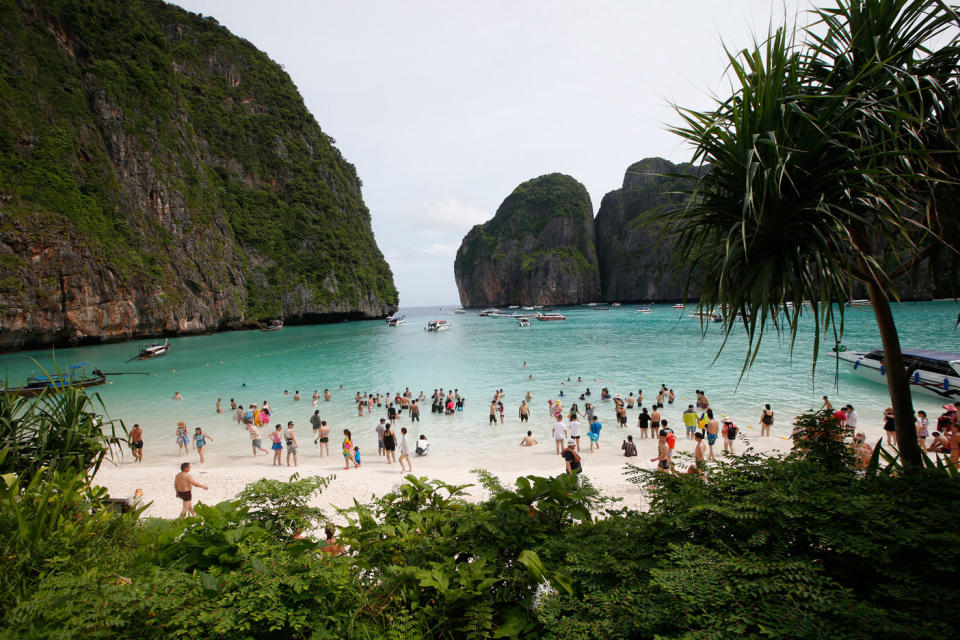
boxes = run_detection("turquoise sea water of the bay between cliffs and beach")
[0,301,960,455]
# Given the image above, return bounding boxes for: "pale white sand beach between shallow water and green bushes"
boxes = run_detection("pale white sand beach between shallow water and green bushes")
[95,427,804,518]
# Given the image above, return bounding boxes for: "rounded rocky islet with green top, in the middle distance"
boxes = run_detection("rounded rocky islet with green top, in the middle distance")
[454,173,600,307]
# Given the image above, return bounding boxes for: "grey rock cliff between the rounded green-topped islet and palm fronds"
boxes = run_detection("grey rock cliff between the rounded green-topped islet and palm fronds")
[595,158,699,302]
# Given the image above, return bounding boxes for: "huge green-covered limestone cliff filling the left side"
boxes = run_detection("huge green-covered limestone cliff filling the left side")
[0,0,397,349]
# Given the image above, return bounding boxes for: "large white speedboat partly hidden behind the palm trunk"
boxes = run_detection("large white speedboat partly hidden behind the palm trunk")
[837,349,960,400]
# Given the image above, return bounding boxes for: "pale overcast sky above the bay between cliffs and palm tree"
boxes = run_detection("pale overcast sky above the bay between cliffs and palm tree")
[176,0,810,306]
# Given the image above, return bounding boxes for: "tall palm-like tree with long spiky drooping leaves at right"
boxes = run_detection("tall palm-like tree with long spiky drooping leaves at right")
[666,0,960,467]
